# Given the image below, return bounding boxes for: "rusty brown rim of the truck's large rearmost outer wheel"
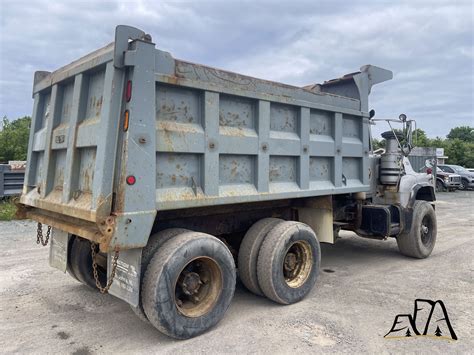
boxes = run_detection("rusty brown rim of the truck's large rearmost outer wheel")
[174,257,223,318]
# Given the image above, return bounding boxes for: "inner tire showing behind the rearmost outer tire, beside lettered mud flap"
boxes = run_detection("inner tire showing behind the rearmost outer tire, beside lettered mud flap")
[130,228,189,323]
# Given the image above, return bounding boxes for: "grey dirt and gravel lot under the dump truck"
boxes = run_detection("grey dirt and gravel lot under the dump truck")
[0,191,474,354]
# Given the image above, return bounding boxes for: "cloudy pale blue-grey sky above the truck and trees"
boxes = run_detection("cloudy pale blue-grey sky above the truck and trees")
[0,0,474,137]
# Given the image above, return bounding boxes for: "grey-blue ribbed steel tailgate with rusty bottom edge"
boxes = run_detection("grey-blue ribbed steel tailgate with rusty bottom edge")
[20,26,147,249]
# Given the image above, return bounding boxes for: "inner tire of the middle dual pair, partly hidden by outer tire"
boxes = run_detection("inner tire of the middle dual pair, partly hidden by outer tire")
[237,218,283,296]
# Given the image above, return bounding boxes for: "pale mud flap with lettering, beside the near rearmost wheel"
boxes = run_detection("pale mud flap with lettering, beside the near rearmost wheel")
[107,248,142,307]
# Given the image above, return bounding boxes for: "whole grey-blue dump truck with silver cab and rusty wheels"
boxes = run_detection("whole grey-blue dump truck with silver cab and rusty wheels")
[18,25,436,339]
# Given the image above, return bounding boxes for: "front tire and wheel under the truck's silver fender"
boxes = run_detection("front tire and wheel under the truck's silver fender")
[397,201,437,259]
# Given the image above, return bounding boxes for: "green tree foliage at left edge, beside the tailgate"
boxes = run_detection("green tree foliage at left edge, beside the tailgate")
[0,116,31,162]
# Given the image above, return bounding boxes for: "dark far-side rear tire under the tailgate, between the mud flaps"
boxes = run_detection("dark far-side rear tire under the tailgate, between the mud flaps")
[71,237,107,291]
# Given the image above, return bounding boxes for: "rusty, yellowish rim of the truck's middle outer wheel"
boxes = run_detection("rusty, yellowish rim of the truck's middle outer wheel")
[283,240,313,288]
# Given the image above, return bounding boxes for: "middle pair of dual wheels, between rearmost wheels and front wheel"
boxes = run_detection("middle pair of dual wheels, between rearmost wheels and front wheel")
[238,218,321,304]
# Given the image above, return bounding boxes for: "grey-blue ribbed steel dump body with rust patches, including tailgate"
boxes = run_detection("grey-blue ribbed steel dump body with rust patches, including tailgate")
[21,29,386,250]
